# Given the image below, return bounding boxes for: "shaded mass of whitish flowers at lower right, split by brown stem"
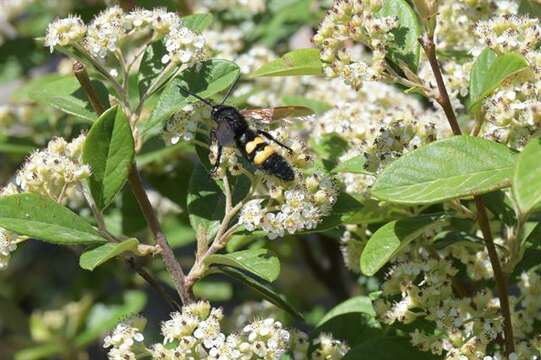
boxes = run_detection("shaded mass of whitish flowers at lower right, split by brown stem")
[375,239,541,360]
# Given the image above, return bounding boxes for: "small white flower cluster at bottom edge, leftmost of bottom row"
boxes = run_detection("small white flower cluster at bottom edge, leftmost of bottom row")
[103,323,145,360]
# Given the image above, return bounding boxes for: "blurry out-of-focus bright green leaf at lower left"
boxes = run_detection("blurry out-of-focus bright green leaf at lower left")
[74,291,146,348]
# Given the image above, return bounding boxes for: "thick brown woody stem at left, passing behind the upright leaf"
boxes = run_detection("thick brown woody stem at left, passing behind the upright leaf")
[73,61,193,304]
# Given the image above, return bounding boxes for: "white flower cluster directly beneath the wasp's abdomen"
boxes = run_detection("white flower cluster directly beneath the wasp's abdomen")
[239,173,337,239]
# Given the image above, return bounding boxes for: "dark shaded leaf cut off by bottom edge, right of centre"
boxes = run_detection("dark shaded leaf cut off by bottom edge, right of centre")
[342,336,440,360]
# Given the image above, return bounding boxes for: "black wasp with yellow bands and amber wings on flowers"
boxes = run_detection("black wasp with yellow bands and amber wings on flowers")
[178,77,312,181]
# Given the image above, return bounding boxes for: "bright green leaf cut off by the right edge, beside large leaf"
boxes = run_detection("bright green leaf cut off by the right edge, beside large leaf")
[513,138,541,215]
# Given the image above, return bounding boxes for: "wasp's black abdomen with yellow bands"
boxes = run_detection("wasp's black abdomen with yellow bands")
[244,136,295,181]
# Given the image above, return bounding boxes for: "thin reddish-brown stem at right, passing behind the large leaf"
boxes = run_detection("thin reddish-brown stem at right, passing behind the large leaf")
[419,34,515,356]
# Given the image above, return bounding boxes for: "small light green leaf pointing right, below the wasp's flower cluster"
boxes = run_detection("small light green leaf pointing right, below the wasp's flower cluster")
[205,249,280,282]
